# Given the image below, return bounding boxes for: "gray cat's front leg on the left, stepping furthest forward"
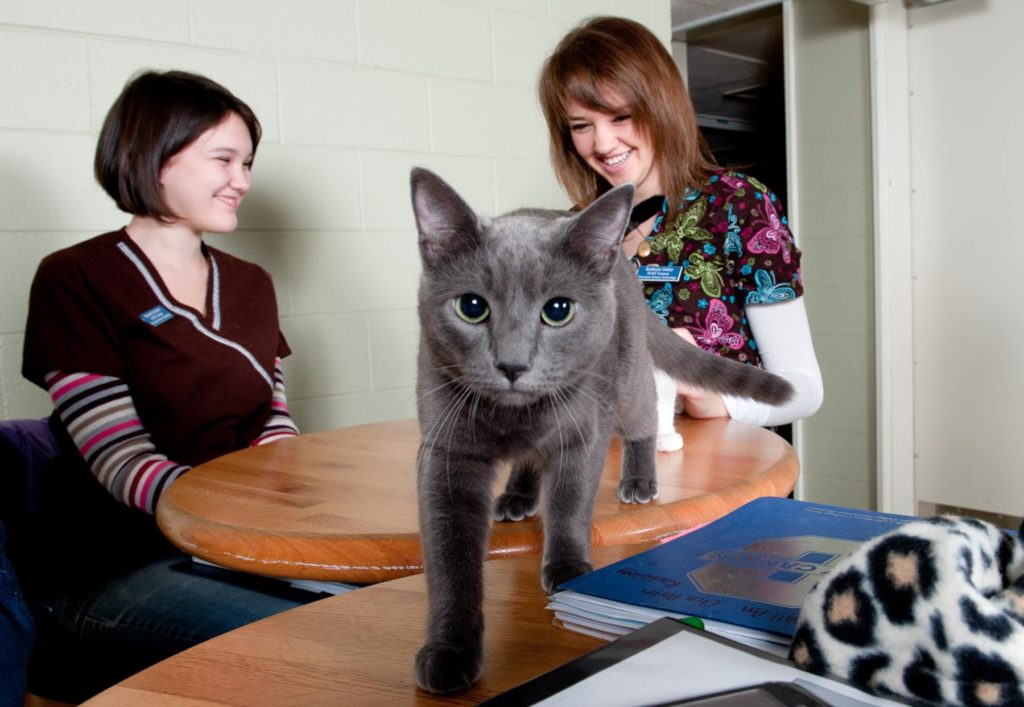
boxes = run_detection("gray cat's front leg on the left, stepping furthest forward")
[416,448,495,693]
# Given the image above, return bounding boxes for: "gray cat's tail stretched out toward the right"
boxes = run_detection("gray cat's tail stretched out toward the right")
[647,313,793,405]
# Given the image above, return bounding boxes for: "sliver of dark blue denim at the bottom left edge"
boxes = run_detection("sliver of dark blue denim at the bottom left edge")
[0,523,34,707]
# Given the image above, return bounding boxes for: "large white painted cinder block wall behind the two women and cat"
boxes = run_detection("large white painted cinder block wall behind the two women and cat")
[0,0,671,431]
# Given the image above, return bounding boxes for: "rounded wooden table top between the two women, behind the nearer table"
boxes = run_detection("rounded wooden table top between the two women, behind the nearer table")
[157,417,799,584]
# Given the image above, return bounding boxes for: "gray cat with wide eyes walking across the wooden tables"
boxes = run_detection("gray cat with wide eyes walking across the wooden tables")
[412,169,791,693]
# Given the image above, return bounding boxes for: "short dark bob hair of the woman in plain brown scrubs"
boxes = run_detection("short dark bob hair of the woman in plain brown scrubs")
[93,71,261,220]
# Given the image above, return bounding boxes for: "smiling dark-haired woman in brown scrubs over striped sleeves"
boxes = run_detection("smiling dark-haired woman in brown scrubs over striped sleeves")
[23,71,348,702]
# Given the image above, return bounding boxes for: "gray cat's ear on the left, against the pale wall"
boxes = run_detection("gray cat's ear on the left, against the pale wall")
[410,167,479,265]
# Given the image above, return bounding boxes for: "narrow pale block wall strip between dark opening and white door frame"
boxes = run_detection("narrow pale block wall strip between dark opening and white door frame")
[790,0,877,508]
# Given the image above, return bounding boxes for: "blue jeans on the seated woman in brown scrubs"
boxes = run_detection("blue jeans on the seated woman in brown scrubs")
[52,556,356,697]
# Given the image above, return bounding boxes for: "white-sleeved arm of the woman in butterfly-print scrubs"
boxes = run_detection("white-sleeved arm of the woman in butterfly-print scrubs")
[677,297,824,425]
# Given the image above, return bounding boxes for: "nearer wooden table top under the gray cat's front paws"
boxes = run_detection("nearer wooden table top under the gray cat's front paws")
[85,544,648,707]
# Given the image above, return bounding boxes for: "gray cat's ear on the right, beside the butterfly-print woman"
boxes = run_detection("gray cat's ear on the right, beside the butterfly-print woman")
[566,183,636,275]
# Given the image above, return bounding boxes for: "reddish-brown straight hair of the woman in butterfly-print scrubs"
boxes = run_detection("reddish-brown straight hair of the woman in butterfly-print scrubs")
[538,17,717,217]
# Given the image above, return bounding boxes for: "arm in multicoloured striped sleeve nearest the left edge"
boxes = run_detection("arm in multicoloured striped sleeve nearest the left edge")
[45,371,191,513]
